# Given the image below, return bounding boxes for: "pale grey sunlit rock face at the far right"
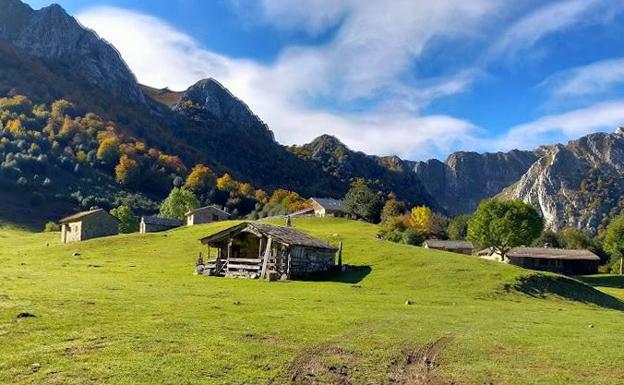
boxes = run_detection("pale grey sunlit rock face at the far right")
[501,128,624,232]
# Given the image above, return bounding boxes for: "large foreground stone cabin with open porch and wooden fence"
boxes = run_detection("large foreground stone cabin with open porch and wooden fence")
[198,222,338,279]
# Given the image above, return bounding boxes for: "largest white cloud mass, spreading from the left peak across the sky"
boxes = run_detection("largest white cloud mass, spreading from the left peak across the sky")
[77,0,492,158]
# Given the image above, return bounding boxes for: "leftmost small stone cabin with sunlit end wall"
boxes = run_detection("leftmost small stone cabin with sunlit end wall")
[59,209,119,243]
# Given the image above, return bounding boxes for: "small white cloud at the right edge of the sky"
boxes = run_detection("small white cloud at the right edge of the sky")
[541,58,624,99]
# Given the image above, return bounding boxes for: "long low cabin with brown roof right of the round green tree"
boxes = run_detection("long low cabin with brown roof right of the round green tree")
[478,247,600,275]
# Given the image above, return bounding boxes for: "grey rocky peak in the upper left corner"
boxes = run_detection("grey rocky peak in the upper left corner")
[0,0,145,104]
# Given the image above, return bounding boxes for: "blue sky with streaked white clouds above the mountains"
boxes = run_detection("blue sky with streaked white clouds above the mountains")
[29,0,624,160]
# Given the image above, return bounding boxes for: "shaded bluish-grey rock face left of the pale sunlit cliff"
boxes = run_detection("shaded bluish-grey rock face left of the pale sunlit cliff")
[412,150,538,215]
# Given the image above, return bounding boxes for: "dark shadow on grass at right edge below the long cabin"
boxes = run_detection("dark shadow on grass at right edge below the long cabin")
[505,274,624,311]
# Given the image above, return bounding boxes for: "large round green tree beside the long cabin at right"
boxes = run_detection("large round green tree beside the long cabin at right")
[466,199,544,260]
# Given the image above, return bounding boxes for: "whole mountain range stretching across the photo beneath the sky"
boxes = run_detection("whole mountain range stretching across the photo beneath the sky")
[0,0,624,231]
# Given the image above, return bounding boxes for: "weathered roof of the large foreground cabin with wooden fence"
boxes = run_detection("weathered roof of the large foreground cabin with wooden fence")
[200,222,337,251]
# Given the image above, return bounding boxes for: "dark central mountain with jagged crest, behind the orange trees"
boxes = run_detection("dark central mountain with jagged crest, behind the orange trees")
[290,135,443,211]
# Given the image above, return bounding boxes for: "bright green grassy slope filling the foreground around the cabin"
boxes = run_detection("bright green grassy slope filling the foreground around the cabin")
[0,219,624,385]
